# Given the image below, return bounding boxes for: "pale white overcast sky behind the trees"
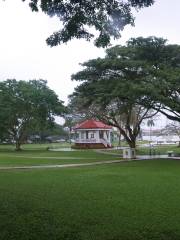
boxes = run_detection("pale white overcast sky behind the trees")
[0,0,180,127]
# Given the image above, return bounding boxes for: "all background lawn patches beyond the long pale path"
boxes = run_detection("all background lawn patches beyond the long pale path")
[0,143,180,167]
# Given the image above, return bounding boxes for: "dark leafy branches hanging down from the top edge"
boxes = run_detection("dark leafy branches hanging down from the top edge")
[23,0,154,47]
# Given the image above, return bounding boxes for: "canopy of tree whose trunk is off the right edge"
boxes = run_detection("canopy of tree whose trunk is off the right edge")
[128,37,180,122]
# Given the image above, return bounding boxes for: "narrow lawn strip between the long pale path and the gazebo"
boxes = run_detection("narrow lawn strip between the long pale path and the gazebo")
[0,148,121,167]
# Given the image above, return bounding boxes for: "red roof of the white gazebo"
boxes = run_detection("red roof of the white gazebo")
[74,119,112,129]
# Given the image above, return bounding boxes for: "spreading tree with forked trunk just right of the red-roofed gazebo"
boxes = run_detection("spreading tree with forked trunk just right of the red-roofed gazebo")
[71,42,160,148]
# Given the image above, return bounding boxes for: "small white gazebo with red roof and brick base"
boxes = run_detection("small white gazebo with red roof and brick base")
[73,119,112,148]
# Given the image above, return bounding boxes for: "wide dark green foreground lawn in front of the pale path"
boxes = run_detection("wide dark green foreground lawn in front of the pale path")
[0,160,180,240]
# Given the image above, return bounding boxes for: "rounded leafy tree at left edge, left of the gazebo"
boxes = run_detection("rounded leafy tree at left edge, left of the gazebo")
[0,79,65,150]
